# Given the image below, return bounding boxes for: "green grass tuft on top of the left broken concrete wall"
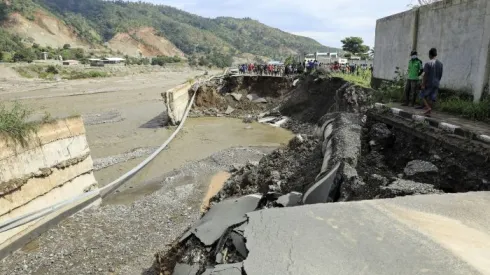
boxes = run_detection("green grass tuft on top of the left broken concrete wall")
[0,103,38,145]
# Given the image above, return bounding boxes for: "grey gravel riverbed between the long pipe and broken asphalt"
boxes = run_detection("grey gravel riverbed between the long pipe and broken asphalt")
[0,147,273,275]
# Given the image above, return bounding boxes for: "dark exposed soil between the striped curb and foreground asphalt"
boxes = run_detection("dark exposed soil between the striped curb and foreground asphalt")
[358,112,490,193]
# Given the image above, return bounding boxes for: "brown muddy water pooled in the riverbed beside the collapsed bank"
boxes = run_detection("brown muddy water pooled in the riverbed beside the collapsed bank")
[96,117,293,207]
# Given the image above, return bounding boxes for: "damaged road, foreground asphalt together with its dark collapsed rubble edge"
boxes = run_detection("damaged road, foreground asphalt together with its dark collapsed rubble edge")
[156,73,490,275]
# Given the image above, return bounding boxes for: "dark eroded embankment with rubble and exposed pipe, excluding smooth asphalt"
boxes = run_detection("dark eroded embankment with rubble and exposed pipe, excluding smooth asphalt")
[156,74,490,274]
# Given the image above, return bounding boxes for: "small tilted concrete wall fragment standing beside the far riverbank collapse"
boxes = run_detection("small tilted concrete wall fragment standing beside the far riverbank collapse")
[162,83,192,125]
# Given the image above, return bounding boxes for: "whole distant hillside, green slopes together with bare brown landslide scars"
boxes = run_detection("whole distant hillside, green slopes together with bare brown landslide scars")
[0,0,334,64]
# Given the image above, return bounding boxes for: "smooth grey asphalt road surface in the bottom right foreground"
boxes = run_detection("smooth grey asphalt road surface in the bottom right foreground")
[244,192,490,275]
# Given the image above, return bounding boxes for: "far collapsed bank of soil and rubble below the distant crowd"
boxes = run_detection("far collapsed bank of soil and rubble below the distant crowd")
[190,70,371,135]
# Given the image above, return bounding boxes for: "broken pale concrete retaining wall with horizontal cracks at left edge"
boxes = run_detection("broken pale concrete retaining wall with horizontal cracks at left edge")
[0,117,97,247]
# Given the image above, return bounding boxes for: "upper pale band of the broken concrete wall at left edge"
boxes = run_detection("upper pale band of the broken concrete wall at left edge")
[0,117,92,198]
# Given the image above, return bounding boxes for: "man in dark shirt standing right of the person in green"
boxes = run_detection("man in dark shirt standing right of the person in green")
[422,48,443,116]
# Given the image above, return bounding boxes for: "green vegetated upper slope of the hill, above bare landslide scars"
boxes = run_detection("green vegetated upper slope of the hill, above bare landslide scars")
[24,0,336,63]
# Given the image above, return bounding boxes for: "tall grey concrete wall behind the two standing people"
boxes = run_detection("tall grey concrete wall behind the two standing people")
[374,0,490,100]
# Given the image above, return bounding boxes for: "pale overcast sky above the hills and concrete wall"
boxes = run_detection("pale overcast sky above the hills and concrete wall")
[132,0,415,47]
